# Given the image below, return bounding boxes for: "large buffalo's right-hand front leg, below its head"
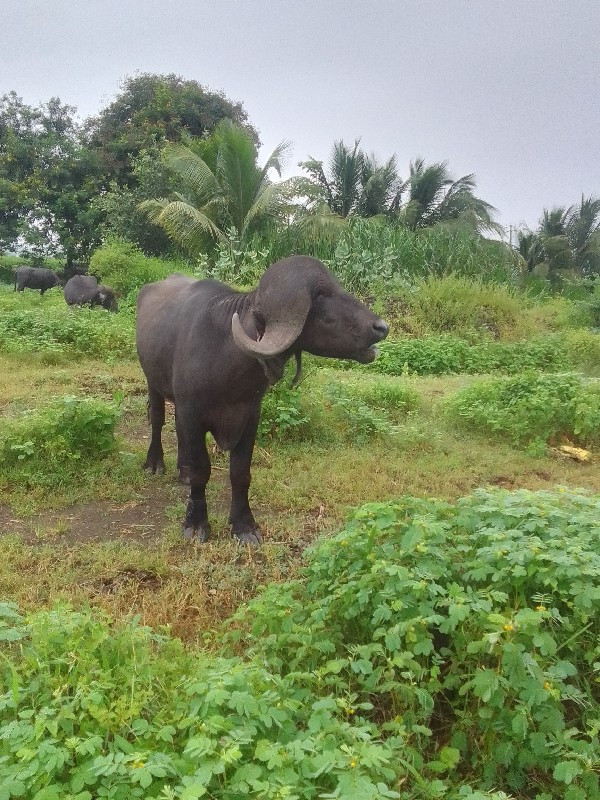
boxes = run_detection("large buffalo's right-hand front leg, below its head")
[229,408,262,544]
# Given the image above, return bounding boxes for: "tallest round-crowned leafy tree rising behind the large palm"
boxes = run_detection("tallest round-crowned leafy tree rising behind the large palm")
[87,73,258,185]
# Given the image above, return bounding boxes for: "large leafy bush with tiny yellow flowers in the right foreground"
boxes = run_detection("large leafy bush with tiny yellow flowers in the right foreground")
[229,490,600,800]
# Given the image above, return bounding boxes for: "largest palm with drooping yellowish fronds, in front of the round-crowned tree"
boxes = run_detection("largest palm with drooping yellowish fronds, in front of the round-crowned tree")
[140,120,295,252]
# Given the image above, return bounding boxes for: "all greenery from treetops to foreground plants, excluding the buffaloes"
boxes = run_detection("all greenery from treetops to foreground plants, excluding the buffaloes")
[0,70,600,800]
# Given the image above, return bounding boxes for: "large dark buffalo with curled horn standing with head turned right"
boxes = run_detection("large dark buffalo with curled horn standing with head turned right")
[136,256,388,543]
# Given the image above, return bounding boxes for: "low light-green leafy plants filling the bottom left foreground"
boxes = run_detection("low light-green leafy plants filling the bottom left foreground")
[0,604,399,800]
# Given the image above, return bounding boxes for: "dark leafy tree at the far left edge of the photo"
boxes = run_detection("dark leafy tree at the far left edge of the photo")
[0,92,100,264]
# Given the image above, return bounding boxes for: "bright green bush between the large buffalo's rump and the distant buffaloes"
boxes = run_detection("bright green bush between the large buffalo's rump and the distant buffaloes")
[90,239,181,295]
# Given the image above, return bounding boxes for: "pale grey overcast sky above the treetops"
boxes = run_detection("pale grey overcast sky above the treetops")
[0,0,600,233]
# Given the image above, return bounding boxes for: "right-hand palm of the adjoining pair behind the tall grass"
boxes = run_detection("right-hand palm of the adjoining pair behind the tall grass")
[399,158,499,232]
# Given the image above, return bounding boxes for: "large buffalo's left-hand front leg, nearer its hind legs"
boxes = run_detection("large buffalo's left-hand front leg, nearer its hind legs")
[181,426,210,542]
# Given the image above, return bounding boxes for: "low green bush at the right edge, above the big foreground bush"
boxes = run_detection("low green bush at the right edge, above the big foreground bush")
[447,372,600,450]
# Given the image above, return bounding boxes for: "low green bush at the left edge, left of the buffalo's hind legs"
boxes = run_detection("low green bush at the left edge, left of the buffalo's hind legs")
[0,397,119,487]
